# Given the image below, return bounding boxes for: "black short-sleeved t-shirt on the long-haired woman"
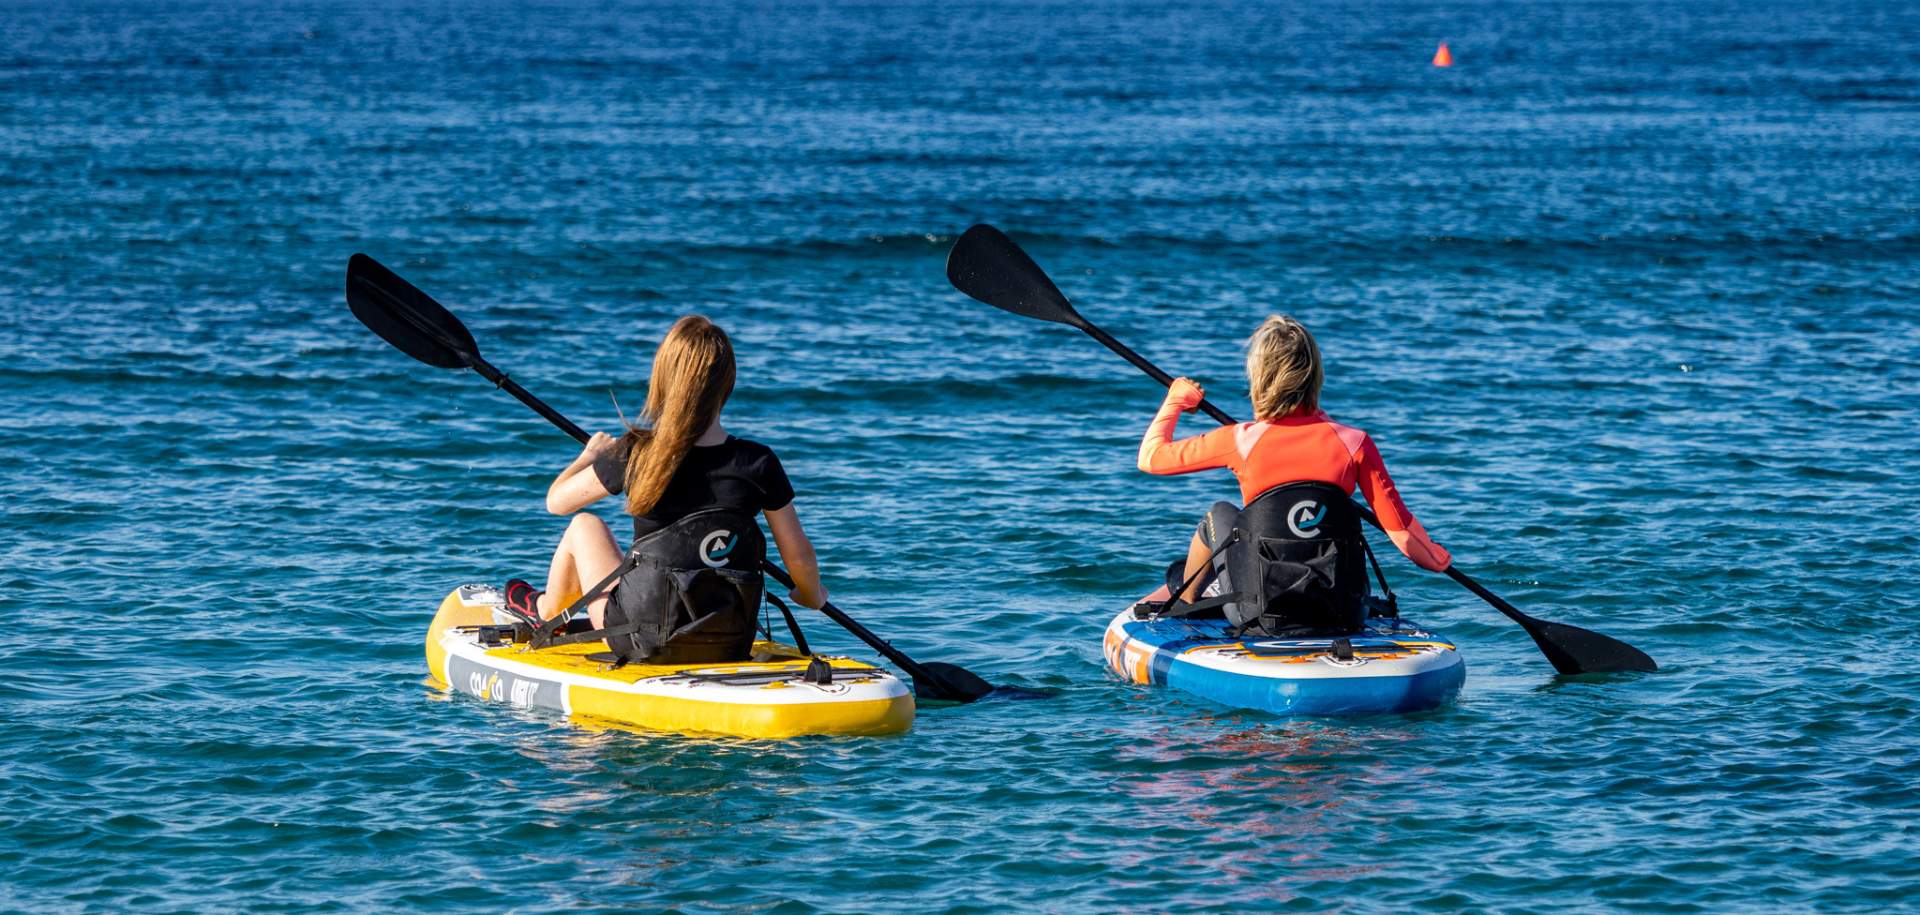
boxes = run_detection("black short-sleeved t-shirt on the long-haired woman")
[593,435,793,537]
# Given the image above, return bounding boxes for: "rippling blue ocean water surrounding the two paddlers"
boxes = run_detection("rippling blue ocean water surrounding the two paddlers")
[0,0,1920,911]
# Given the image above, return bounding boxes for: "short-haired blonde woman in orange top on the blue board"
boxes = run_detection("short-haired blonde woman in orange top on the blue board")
[1139,315,1453,602]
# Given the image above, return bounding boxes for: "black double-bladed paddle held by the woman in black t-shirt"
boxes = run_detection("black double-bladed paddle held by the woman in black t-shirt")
[348,253,993,702]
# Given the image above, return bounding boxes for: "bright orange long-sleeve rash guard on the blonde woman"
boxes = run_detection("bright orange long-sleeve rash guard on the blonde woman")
[1140,391,1453,572]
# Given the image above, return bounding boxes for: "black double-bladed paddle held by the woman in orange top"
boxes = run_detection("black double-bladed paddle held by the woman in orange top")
[947,224,1659,673]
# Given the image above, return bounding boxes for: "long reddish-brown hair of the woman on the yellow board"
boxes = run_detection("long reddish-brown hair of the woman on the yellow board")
[624,315,733,514]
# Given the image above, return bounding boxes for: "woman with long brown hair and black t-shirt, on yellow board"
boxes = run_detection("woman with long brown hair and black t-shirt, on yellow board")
[507,315,828,629]
